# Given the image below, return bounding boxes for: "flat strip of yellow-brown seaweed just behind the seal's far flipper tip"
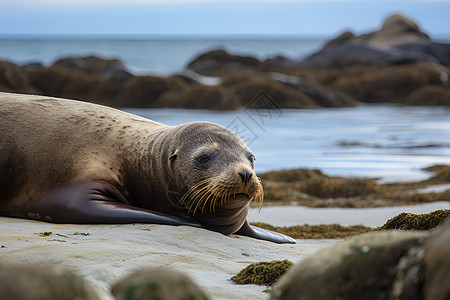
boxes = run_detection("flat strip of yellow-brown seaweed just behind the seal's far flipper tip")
[252,223,373,239]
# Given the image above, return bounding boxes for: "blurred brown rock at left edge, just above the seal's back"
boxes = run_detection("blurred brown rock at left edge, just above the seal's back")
[0,61,36,94]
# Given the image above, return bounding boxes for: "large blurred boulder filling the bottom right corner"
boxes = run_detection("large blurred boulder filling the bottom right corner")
[271,220,450,300]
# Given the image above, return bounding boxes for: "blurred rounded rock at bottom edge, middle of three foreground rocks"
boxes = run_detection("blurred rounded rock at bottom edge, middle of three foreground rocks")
[111,269,208,300]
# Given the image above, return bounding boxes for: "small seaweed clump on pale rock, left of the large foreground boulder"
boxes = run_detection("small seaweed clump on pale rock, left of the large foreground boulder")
[231,259,292,286]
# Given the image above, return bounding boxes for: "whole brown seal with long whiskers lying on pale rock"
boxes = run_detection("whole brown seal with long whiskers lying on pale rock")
[0,93,295,243]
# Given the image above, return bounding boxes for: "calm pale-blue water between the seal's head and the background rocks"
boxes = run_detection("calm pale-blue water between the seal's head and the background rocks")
[126,104,450,182]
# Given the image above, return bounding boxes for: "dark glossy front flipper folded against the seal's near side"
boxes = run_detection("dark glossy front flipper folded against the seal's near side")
[38,181,201,227]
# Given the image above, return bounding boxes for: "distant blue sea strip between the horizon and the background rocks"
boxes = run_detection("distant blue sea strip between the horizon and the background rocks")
[0,36,325,75]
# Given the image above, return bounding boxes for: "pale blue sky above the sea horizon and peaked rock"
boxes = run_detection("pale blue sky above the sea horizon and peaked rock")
[0,0,450,38]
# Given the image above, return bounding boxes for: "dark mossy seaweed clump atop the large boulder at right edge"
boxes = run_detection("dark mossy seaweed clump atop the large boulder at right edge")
[379,209,450,230]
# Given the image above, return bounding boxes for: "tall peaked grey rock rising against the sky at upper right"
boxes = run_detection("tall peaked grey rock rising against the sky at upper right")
[299,15,450,68]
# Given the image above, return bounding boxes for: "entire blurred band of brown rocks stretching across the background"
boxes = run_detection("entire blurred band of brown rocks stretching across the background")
[0,15,450,110]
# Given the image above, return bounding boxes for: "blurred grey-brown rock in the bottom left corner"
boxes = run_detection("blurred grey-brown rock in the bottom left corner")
[0,264,104,300]
